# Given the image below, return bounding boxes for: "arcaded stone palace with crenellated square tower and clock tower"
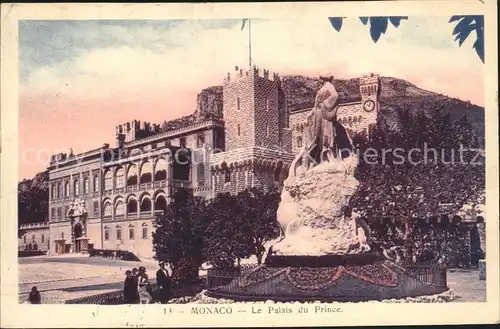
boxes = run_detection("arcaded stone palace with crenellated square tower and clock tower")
[19,67,380,258]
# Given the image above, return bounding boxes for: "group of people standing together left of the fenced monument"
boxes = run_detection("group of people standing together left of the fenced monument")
[123,261,172,304]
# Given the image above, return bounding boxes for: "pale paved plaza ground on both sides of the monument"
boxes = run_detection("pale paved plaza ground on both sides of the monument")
[18,255,486,304]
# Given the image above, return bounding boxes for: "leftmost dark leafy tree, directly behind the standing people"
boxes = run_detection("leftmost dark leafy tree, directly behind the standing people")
[153,189,209,284]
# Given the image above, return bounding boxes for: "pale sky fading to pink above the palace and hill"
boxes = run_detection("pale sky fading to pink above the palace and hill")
[19,16,484,179]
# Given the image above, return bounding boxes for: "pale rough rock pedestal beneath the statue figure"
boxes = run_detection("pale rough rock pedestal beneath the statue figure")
[273,157,358,256]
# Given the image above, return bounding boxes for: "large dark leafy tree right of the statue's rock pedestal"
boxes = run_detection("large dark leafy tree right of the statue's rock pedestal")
[350,109,485,262]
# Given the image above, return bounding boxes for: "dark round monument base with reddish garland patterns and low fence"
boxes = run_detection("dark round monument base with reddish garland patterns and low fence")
[207,254,448,302]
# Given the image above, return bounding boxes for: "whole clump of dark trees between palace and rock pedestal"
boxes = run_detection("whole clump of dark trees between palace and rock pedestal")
[153,188,280,276]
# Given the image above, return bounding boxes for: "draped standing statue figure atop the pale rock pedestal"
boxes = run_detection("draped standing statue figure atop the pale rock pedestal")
[290,76,339,176]
